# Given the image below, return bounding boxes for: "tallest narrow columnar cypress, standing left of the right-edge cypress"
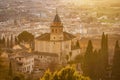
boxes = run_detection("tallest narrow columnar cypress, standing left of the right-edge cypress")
[100,33,108,79]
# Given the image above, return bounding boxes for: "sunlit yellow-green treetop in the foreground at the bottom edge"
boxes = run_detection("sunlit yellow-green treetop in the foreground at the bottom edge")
[41,66,90,80]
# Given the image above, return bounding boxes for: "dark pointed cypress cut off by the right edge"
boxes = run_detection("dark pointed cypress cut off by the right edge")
[111,41,120,80]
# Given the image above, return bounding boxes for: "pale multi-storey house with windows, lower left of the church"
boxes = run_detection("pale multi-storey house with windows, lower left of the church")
[10,51,34,73]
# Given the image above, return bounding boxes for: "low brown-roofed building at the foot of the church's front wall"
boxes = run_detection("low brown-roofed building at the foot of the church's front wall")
[34,52,59,71]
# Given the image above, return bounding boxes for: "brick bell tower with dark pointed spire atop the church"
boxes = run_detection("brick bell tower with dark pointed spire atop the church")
[50,10,63,41]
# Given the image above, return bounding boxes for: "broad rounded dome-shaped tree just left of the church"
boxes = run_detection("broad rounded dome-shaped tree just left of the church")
[18,31,34,42]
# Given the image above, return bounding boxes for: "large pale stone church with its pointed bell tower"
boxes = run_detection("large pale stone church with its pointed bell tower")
[35,13,80,61]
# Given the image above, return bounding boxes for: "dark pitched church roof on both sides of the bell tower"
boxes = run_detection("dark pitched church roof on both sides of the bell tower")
[36,32,75,41]
